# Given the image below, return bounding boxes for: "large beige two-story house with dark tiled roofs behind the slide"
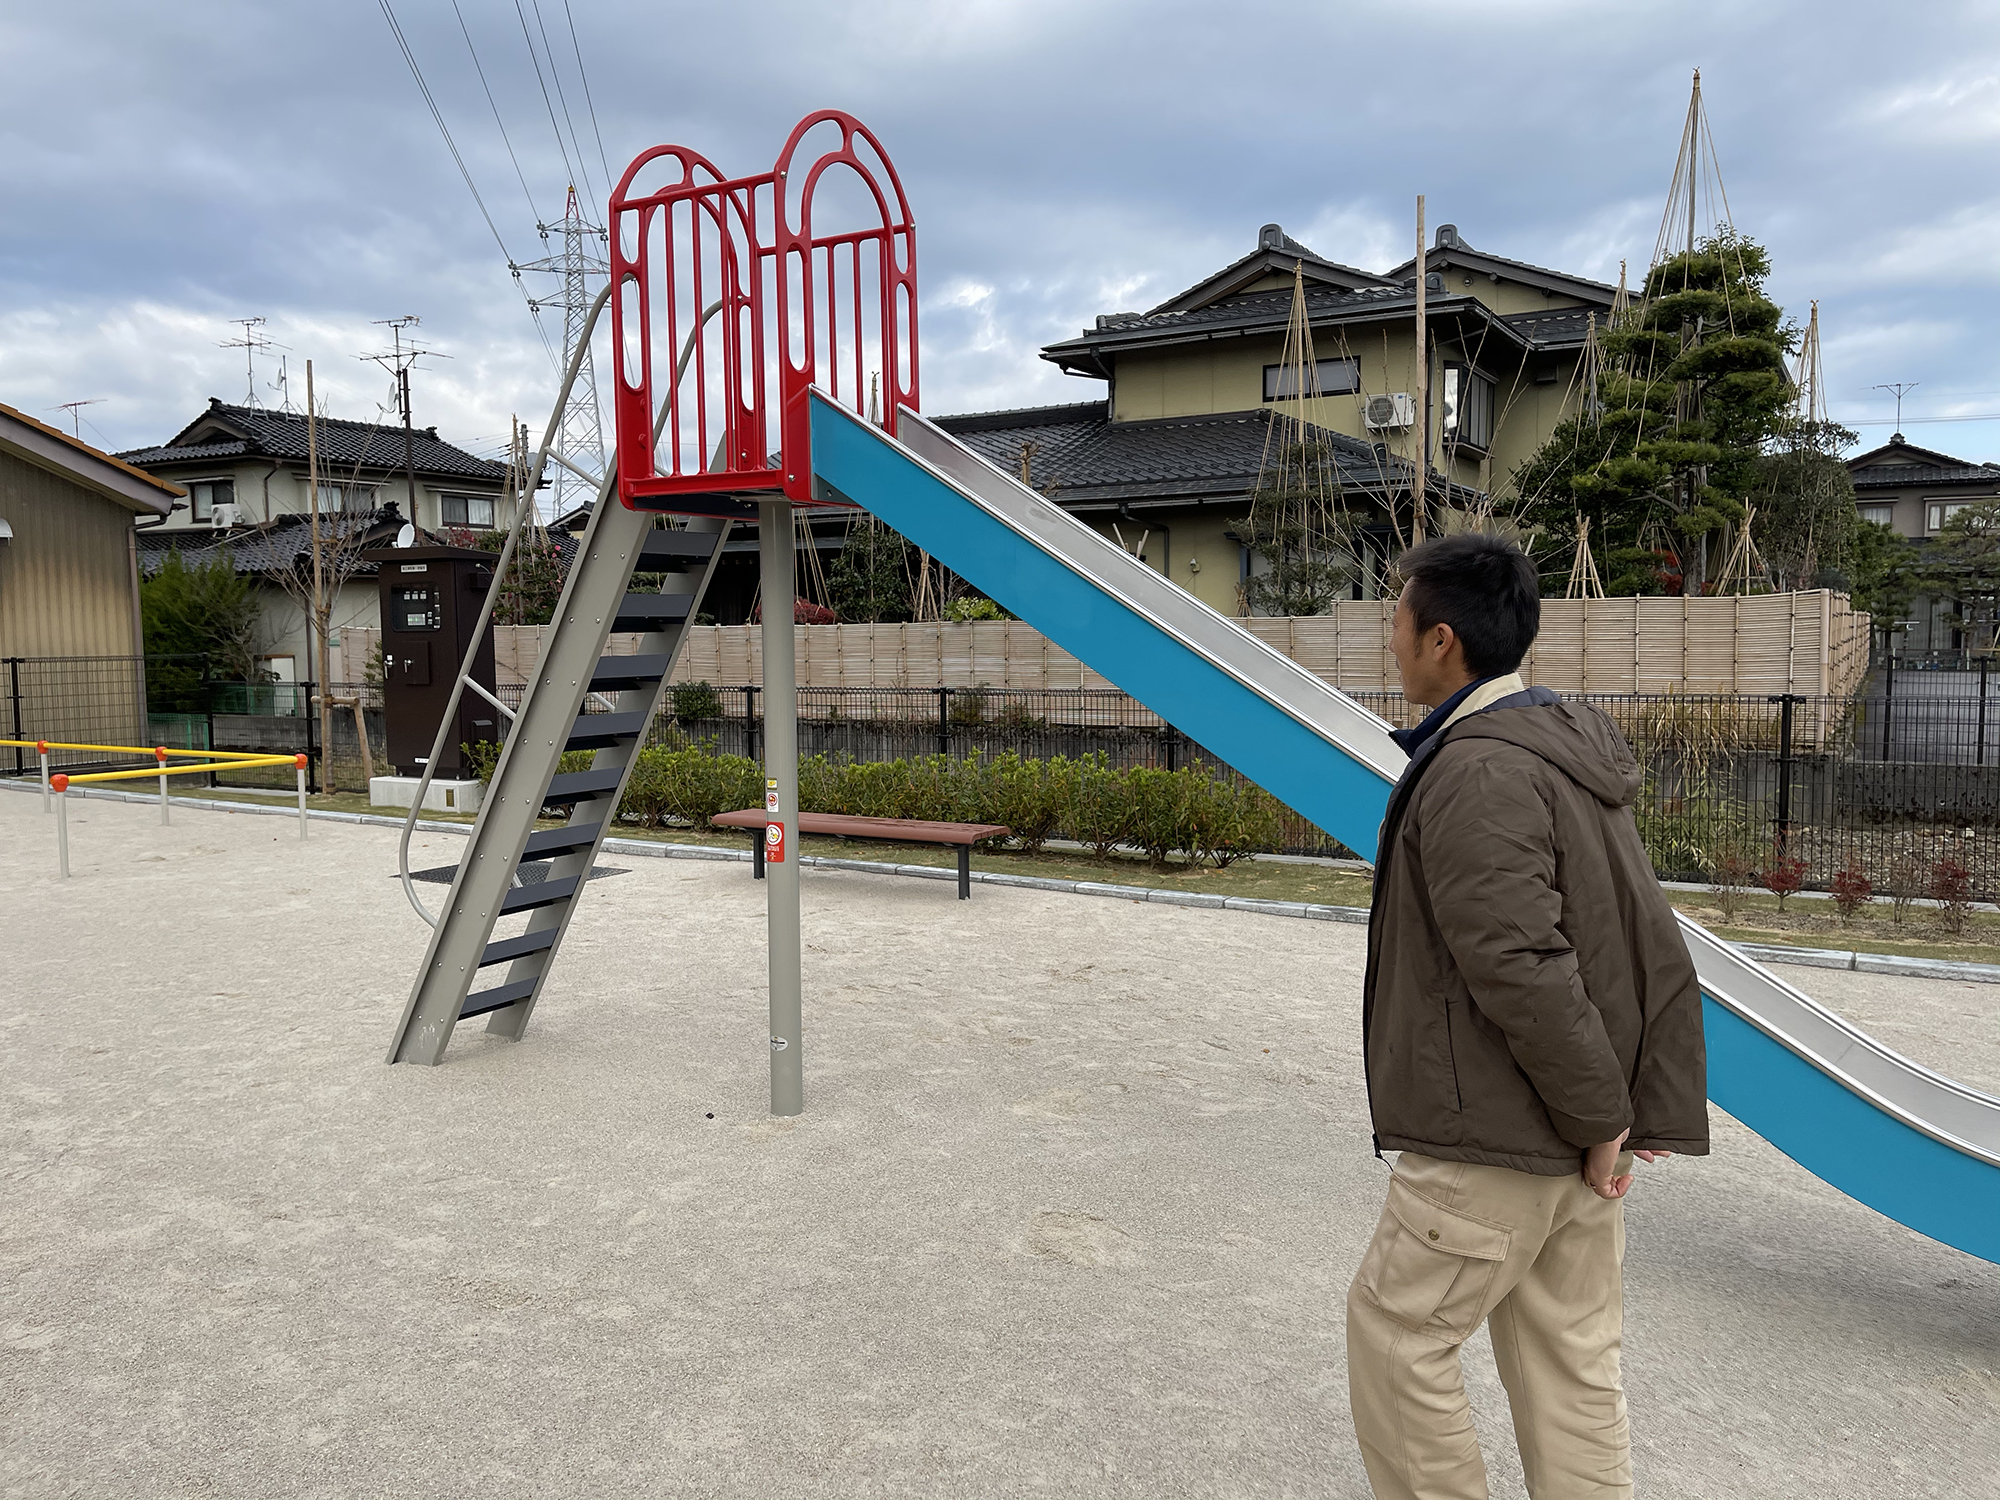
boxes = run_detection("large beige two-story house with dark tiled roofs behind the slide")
[940,224,1616,614]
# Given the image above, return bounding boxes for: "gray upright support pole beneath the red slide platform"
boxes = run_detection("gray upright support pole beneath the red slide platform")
[756,500,806,1114]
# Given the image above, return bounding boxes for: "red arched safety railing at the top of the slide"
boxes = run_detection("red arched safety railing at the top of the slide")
[610,110,918,516]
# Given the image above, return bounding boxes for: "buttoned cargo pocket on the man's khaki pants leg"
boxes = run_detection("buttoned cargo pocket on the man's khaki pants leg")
[1360,1178,1514,1342]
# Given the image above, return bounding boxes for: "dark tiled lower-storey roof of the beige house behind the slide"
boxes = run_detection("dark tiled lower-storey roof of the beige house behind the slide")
[936,402,1464,506]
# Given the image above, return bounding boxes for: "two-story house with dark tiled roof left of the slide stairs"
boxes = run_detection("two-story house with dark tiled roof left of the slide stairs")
[120,398,514,682]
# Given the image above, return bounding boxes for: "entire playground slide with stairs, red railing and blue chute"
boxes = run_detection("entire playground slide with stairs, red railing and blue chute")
[388,110,2000,1262]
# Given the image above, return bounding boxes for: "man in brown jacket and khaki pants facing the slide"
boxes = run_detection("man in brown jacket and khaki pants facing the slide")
[1348,536,1708,1500]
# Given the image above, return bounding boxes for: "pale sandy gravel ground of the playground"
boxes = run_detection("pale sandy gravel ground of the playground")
[0,794,2000,1500]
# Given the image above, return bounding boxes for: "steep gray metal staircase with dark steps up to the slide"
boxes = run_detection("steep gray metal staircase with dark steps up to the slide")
[388,498,730,1064]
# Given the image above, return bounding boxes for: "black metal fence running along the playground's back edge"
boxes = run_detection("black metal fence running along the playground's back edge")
[11,658,2000,900]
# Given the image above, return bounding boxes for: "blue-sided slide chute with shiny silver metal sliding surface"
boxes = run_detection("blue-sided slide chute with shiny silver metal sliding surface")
[812,392,2000,1264]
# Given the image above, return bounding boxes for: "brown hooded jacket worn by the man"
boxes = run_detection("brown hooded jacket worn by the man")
[1362,688,1708,1176]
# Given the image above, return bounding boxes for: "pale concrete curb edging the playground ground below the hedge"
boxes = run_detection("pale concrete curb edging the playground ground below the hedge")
[15,780,2000,984]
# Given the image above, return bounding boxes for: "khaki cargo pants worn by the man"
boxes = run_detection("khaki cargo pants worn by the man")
[1348,1152,1632,1500]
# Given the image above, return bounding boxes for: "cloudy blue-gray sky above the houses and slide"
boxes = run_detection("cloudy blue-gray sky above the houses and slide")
[0,0,2000,476]
